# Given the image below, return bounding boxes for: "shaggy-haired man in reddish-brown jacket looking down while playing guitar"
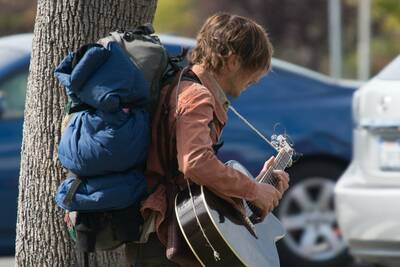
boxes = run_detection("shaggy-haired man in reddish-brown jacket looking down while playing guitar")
[127,14,289,267]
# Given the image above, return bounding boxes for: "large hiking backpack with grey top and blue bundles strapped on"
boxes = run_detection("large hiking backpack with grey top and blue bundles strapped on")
[55,24,191,265]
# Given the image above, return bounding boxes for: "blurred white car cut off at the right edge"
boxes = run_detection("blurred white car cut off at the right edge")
[335,55,400,267]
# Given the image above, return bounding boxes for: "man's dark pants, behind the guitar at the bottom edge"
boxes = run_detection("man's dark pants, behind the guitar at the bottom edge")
[125,233,179,267]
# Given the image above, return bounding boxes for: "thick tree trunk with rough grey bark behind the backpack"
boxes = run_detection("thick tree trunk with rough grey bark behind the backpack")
[15,0,157,267]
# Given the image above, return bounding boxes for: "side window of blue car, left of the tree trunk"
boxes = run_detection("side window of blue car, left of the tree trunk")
[0,71,28,119]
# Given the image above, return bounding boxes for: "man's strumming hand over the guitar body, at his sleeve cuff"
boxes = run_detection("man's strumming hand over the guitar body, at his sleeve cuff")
[251,183,282,221]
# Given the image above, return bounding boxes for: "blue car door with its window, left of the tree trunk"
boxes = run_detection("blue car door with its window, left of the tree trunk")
[0,68,28,254]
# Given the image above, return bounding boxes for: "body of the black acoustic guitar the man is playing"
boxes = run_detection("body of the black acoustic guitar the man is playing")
[175,162,285,267]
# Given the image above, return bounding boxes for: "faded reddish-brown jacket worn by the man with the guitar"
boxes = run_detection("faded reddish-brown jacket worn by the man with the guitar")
[142,65,256,266]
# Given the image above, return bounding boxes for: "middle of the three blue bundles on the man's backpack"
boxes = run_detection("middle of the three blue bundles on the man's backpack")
[58,109,150,176]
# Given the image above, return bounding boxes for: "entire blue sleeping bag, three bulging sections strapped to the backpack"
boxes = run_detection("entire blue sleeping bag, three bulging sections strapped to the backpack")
[55,42,150,211]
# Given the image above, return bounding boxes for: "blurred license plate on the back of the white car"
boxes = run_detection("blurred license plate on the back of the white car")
[379,139,400,171]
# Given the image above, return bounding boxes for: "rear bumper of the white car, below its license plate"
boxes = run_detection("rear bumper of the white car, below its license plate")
[335,171,400,266]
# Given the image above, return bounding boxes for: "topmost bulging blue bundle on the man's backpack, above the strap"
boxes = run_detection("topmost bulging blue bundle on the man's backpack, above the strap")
[55,42,150,112]
